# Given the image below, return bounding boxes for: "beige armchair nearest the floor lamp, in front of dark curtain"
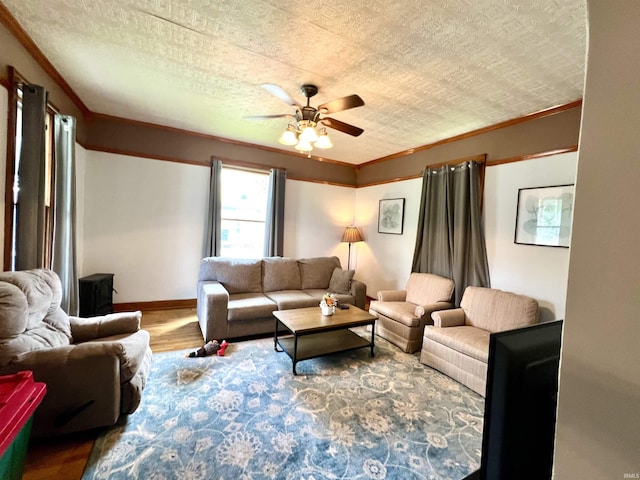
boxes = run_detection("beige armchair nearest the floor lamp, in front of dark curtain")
[369,272,455,353]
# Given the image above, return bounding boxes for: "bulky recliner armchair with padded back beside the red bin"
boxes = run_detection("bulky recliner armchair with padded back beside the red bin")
[0,269,151,436]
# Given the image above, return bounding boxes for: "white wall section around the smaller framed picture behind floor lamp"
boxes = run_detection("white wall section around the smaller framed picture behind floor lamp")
[351,178,422,298]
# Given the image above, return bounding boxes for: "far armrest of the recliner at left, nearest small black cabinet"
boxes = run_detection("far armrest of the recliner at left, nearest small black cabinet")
[69,311,142,343]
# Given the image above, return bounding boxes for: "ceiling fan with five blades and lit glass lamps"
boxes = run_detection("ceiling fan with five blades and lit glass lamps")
[246,83,364,153]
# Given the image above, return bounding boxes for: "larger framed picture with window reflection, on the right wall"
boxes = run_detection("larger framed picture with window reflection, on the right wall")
[514,184,575,247]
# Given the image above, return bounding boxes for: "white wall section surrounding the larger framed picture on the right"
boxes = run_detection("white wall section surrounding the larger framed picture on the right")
[484,153,577,321]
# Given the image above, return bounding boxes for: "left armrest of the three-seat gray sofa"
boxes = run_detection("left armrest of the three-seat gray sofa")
[197,281,229,342]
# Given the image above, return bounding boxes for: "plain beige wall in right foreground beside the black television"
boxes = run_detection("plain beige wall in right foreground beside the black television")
[554,0,640,480]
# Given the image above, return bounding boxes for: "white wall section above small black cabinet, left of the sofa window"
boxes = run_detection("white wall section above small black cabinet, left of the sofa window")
[81,151,209,303]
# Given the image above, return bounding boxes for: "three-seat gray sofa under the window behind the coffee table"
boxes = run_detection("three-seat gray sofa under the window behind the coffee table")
[197,257,367,341]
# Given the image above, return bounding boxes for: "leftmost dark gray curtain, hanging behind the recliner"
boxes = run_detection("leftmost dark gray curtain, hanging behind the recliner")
[15,85,47,270]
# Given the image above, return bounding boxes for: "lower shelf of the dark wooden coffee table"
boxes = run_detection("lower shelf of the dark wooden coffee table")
[277,329,373,375]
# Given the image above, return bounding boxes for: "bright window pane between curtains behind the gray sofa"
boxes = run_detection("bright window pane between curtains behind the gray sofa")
[220,166,269,258]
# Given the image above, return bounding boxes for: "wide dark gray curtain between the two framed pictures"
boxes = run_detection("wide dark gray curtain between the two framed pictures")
[412,162,490,306]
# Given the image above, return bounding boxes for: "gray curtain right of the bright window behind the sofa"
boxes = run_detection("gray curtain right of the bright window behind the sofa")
[264,168,287,257]
